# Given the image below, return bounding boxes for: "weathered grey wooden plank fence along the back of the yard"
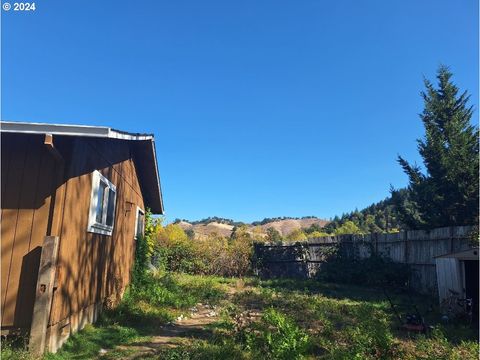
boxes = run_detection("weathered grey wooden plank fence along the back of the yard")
[254,226,473,293]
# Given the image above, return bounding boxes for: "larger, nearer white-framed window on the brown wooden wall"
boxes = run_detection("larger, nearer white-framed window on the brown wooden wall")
[88,170,117,235]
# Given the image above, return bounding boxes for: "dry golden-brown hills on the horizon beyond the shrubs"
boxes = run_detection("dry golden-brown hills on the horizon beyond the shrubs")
[175,216,328,237]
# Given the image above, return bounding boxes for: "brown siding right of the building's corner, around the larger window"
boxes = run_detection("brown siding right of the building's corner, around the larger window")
[50,139,144,325]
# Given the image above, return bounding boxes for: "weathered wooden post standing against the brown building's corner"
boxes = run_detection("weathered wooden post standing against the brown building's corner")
[29,236,58,355]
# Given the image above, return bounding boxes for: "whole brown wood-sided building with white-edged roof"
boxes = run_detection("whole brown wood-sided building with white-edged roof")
[0,121,163,352]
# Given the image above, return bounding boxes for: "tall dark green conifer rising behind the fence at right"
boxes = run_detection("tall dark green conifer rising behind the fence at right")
[392,66,479,229]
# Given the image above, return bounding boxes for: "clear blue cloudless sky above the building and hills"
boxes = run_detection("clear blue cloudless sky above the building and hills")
[1,0,479,221]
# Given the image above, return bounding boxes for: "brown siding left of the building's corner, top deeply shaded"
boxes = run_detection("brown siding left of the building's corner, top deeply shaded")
[1,135,55,328]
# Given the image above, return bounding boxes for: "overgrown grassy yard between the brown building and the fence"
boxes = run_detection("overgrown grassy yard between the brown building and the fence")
[2,274,479,360]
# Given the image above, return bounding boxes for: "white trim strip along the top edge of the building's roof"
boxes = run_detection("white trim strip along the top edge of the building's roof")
[0,121,153,140]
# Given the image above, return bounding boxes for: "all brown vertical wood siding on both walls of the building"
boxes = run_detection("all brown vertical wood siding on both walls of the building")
[0,134,145,330]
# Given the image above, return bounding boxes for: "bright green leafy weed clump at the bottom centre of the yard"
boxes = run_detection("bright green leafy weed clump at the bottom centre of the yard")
[244,308,309,360]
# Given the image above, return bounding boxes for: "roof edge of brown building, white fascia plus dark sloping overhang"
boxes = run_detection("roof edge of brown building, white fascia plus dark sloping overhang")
[0,121,164,214]
